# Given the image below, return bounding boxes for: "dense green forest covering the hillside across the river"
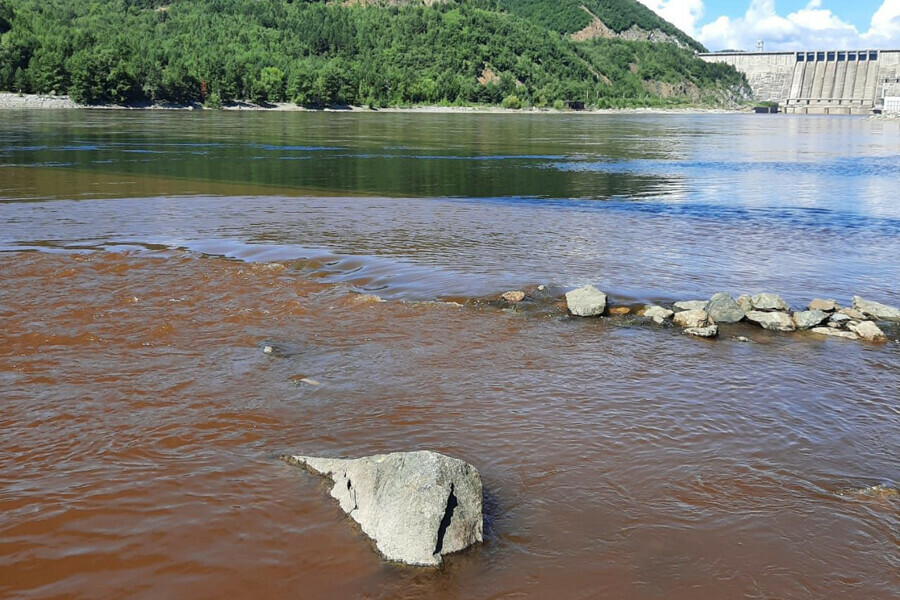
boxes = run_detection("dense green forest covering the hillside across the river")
[0,0,745,108]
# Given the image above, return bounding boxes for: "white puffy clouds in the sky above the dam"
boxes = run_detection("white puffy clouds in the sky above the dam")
[640,0,900,50]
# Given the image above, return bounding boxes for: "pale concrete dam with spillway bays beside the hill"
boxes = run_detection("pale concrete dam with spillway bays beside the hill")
[700,50,900,115]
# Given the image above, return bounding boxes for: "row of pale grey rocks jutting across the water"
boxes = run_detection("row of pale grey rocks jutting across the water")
[501,285,900,343]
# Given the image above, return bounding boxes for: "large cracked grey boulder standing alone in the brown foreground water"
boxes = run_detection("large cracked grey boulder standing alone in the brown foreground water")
[288,451,483,566]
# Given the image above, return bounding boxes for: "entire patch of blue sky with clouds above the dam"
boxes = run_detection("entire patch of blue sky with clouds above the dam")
[638,0,900,51]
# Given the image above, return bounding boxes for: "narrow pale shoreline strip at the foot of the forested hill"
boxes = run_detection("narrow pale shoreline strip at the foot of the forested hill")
[0,92,751,115]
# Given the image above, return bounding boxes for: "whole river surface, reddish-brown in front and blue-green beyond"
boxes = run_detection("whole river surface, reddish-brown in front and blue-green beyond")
[0,113,900,600]
